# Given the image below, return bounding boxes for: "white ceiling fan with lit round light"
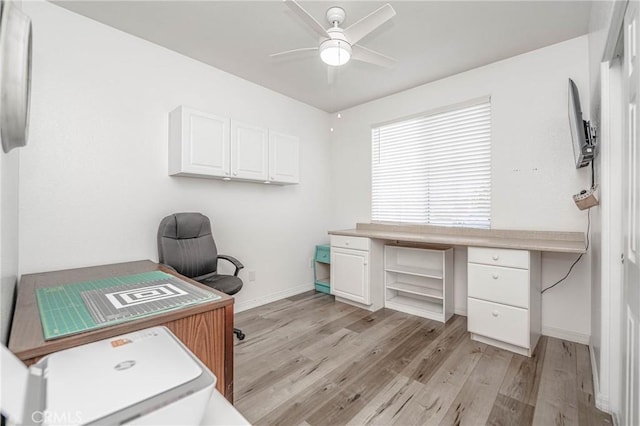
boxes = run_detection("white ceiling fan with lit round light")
[269,0,396,67]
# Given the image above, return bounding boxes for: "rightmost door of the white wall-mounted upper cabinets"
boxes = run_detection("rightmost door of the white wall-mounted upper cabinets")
[269,130,300,183]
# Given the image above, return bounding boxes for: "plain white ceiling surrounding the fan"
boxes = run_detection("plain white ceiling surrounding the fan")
[55,0,591,112]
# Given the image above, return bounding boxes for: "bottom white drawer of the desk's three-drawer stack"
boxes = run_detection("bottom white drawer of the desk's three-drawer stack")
[467,298,530,348]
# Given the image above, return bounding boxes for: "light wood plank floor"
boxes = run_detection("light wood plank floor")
[234,292,612,426]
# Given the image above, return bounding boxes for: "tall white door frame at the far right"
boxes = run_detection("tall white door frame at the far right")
[590,1,628,424]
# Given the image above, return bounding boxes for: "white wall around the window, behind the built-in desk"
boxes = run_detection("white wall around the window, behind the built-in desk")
[331,36,590,343]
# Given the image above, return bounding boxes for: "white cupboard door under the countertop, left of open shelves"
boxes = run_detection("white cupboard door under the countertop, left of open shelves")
[331,247,371,305]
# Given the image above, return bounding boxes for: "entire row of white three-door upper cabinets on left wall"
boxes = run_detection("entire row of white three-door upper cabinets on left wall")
[169,106,300,184]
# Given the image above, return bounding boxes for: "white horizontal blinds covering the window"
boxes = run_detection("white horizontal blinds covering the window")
[371,99,491,228]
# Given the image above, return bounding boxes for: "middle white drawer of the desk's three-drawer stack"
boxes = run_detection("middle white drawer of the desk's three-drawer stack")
[467,263,529,309]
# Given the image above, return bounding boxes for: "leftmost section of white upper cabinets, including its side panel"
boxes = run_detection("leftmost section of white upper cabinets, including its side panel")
[169,106,231,177]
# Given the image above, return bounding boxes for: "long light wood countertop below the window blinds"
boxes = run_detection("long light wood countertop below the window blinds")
[329,223,586,253]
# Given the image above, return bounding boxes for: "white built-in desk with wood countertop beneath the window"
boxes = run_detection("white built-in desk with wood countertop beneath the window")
[329,223,586,356]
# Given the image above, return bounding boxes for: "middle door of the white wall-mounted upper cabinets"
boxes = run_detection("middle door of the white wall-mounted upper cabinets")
[231,120,269,181]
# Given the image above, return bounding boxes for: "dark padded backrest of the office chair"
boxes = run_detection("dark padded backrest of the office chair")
[158,213,218,278]
